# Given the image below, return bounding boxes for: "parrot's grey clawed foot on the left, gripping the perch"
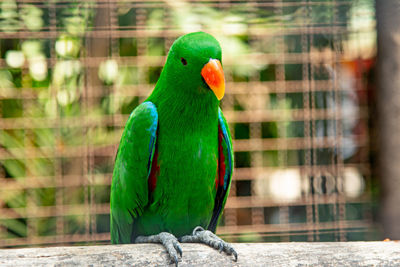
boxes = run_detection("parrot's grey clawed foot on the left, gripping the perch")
[135,232,182,266]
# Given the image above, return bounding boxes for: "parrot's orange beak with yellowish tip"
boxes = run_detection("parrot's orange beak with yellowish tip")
[201,58,225,100]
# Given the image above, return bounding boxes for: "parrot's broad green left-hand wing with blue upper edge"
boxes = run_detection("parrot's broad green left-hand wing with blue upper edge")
[110,102,158,244]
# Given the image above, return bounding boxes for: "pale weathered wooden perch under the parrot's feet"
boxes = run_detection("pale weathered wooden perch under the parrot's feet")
[0,241,400,267]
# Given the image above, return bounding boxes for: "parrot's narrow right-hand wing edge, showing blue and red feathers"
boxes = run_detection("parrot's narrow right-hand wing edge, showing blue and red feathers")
[208,108,233,232]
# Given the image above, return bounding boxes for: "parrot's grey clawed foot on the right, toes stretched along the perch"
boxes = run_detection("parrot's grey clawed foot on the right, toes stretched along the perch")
[179,226,237,261]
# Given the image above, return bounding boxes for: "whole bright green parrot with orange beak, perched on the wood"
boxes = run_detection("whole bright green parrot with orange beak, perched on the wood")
[110,32,237,265]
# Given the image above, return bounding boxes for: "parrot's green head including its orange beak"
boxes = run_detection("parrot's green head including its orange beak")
[161,32,225,100]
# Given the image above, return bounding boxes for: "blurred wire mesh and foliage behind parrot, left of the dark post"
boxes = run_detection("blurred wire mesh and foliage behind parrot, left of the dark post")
[0,0,384,247]
